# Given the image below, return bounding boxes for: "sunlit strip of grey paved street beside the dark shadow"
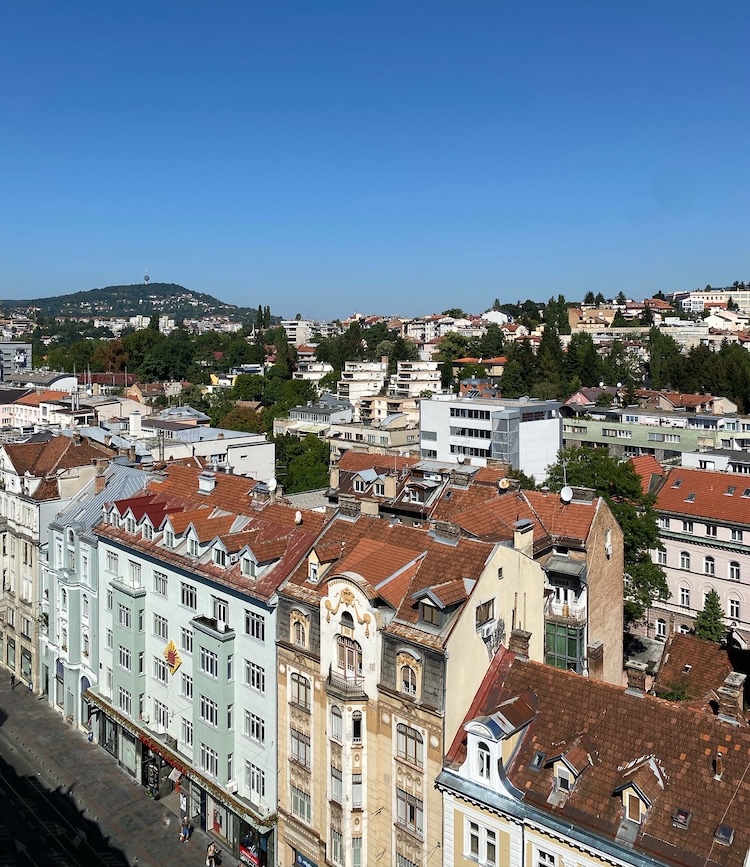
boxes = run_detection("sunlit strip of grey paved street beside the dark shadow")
[0,678,238,867]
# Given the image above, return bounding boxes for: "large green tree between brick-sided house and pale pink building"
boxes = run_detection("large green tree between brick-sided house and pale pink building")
[547,448,669,622]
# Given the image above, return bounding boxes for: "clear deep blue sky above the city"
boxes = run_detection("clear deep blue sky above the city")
[0,0,750,318]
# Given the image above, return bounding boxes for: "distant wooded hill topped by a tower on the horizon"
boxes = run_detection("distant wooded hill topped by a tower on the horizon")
[0,283,256,321]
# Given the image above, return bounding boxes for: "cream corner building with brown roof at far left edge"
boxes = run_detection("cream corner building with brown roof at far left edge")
[0,435,113,692]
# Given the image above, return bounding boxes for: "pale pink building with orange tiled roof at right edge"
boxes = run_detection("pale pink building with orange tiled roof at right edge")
[648,467,750,644]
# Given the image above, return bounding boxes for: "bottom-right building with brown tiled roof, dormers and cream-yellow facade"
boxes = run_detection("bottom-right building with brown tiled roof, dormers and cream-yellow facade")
[437,652,750,867]
